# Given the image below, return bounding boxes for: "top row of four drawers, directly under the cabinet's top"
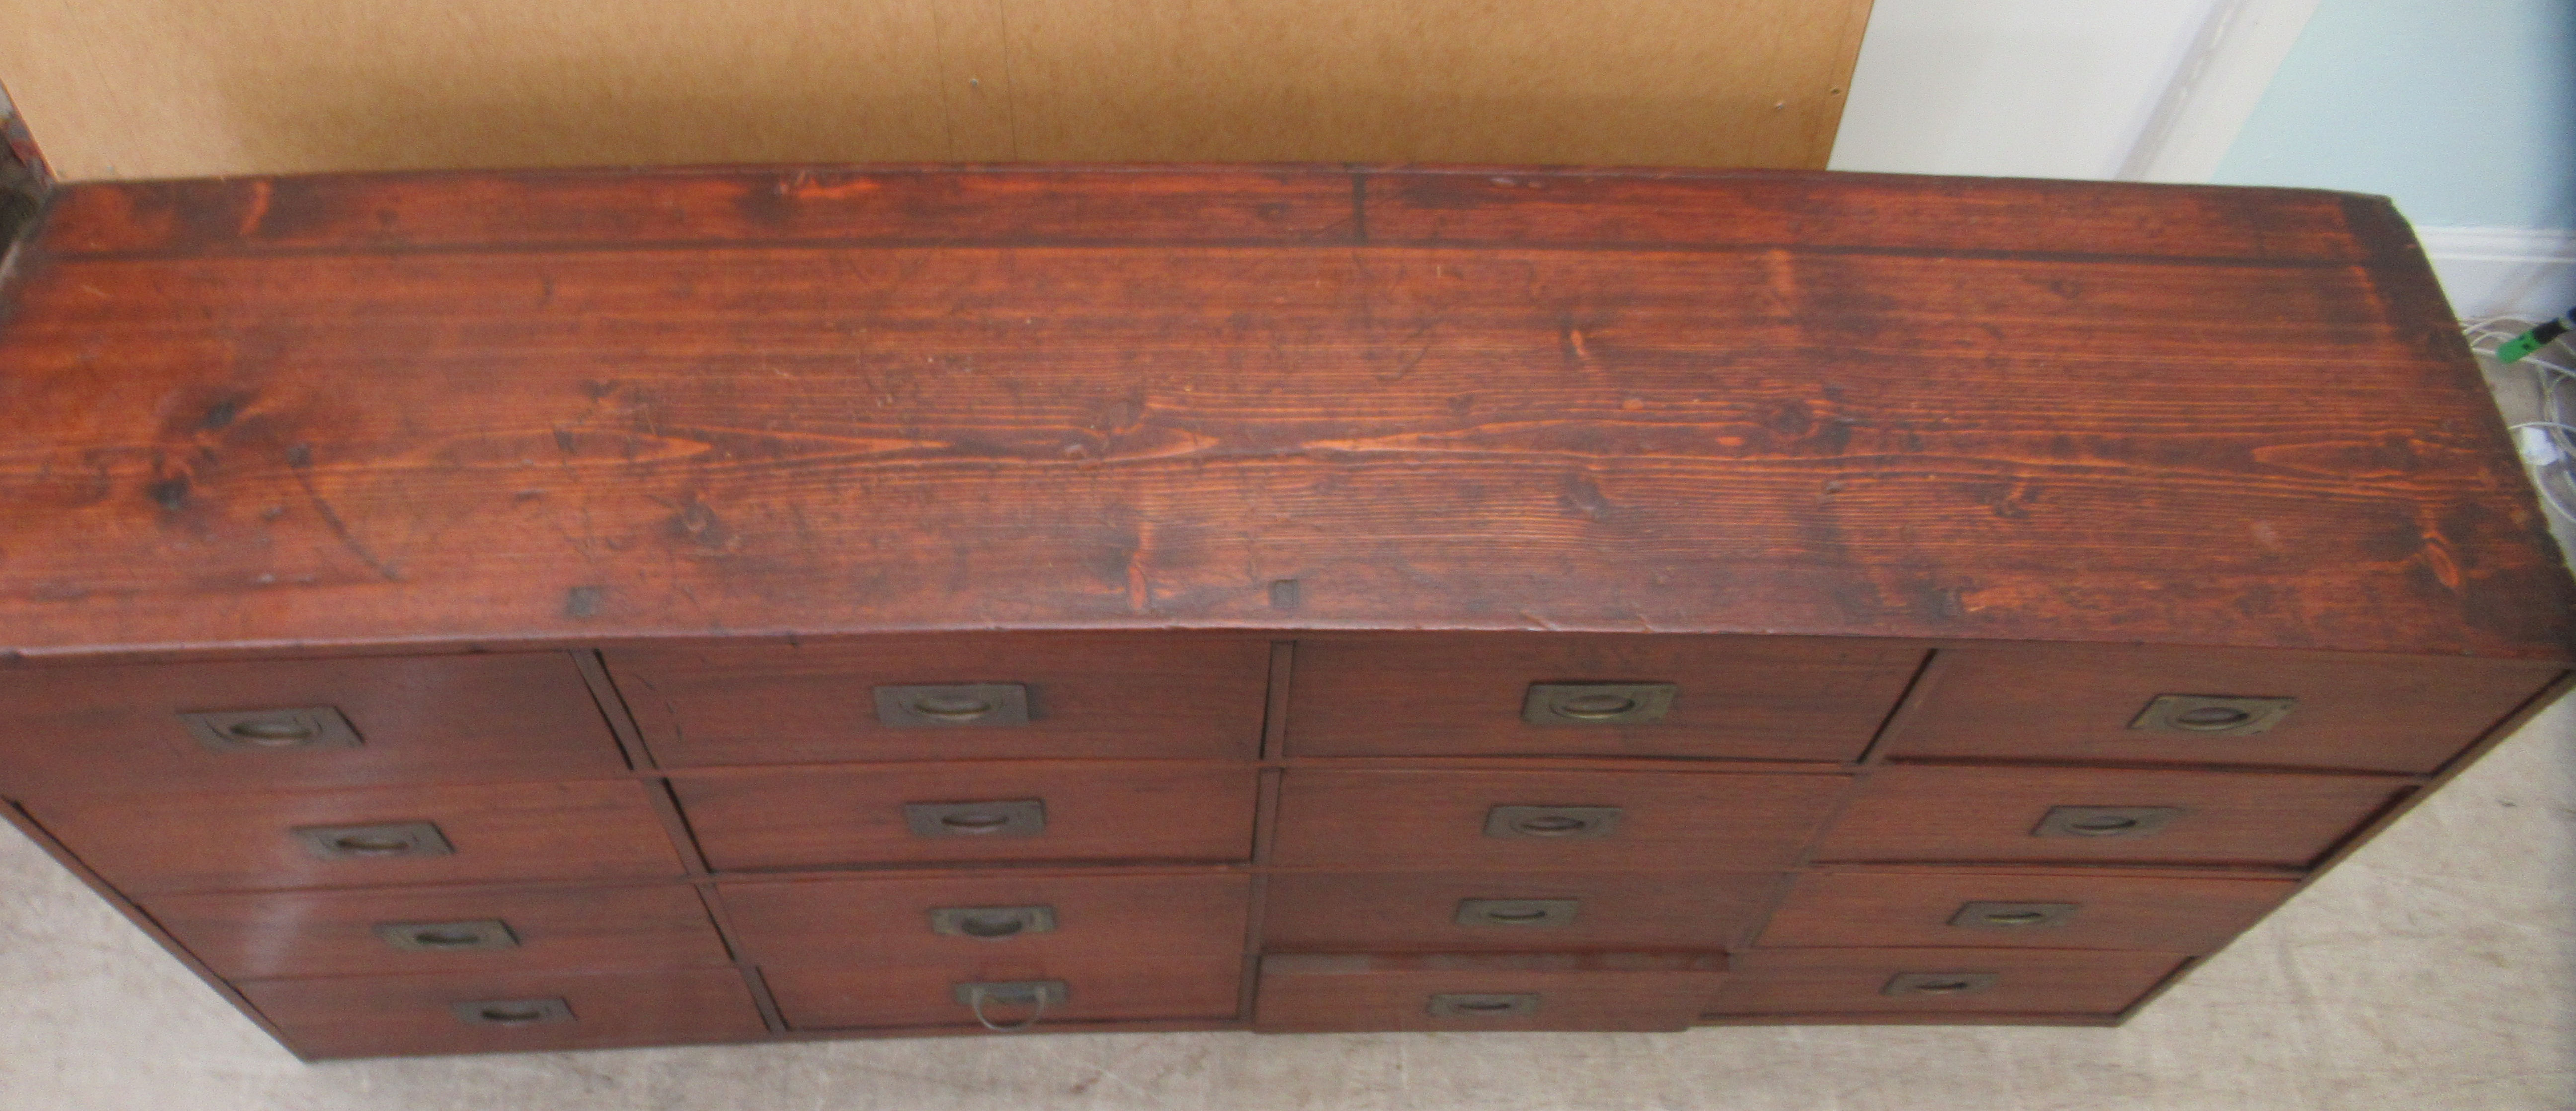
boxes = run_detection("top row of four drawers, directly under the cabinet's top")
[0,634,2550,796]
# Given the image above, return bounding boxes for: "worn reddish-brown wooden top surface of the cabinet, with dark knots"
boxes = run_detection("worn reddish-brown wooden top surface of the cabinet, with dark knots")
[0,167,2571,660]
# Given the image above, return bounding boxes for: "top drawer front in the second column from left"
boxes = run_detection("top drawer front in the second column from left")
[608,634,1270,768]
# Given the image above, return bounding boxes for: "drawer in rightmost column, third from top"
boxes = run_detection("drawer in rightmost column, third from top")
[1760,872,2298,954]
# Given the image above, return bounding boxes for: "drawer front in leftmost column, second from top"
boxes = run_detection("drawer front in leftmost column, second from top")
[28,779,680,894]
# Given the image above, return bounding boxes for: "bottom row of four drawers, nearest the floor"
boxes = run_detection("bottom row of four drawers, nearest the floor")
[240,949,2189,1057]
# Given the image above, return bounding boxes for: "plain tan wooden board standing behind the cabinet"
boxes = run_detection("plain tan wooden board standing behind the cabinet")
[0,0,1870,180]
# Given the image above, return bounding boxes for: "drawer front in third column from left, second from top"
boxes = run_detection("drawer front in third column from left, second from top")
[1273,768,1850,872]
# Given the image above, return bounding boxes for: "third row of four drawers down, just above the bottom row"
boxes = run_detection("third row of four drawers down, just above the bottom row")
[142,869,2295,979]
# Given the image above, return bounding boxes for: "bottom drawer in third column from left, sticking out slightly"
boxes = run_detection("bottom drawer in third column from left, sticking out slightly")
[1252,954,1726,1033]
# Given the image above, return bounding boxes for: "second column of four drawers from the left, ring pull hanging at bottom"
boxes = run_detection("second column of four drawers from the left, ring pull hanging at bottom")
[605,634,1270,1031]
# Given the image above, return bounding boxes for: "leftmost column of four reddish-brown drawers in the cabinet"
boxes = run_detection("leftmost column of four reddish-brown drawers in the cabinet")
[0,652,768,1057]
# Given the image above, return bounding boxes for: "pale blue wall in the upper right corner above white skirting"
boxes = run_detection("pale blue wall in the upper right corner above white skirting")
[2215,0,2576,227]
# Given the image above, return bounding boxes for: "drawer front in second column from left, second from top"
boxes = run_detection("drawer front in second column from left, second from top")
[672,763,1257,869]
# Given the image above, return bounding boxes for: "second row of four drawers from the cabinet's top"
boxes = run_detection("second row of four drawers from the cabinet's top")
[28,760,2409,894]
